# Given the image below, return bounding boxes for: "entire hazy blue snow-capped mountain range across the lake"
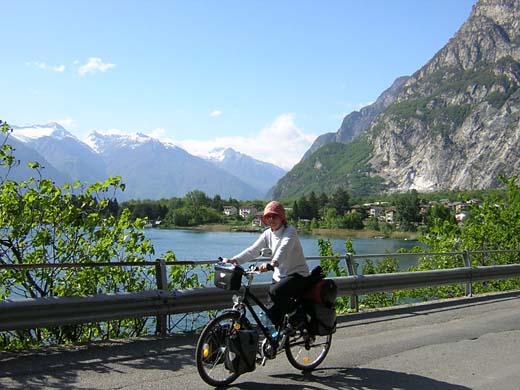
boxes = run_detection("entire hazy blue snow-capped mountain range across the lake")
[5,123,284,201]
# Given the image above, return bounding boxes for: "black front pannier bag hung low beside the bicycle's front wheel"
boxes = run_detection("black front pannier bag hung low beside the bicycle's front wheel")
[224,330,258,374]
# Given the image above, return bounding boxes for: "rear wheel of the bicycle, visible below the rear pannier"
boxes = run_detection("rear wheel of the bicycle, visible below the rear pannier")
[285,329,332,371]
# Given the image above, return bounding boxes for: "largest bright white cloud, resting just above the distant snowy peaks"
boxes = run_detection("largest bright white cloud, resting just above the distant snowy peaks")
[174,114,316,170]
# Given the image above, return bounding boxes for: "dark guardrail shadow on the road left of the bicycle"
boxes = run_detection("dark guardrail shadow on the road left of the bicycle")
[0,334,197,389]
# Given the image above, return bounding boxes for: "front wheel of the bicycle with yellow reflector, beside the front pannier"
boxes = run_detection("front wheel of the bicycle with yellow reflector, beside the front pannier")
[195,312,240,387]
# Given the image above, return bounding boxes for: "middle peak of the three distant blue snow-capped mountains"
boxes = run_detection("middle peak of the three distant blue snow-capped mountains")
[87,132,265,200]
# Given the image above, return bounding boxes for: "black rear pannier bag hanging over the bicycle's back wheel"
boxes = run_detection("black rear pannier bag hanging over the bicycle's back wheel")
[304,279,338,336]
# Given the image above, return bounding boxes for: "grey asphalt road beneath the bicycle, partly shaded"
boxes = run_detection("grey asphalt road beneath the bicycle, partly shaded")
[0,292,520,390]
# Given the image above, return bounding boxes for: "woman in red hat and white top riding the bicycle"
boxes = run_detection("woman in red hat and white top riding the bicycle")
[223,201,309,326]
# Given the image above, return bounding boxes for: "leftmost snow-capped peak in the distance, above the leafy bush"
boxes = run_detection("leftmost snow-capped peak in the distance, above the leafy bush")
[12,123,107,183]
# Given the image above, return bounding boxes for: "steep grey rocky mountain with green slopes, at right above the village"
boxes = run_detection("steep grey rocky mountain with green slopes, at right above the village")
[272,0,520,197]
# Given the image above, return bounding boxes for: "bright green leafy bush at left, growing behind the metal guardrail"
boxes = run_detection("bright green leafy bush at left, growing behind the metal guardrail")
[0,121,205,349]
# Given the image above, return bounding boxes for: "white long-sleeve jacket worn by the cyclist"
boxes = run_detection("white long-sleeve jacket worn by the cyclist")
[233,226,309,281]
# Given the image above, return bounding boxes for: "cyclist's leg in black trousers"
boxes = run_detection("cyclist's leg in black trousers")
[269,274,305,326]
